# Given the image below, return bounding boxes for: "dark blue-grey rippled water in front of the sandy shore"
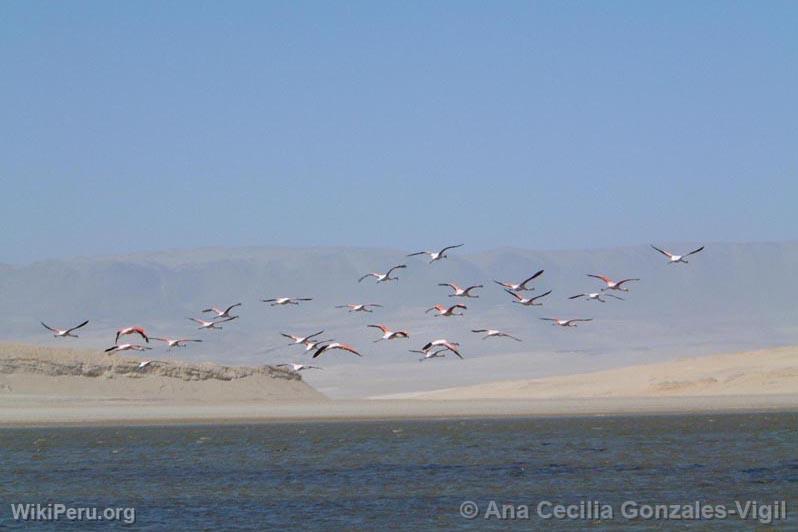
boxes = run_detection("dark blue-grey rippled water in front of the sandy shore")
[0,414,798,530]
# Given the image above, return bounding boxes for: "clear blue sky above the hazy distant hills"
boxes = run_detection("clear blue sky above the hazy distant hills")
[0,1,798,263]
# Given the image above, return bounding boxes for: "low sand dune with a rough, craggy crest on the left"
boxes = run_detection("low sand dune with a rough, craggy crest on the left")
[0,344,326,406]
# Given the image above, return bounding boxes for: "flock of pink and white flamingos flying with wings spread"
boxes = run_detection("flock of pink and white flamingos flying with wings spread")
[41,244,704,371]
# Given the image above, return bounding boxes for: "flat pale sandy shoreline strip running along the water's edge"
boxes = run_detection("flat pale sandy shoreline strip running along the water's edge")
[0,394,798,429]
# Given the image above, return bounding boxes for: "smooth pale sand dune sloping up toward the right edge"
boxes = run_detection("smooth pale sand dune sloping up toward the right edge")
[386,347,798,399]
